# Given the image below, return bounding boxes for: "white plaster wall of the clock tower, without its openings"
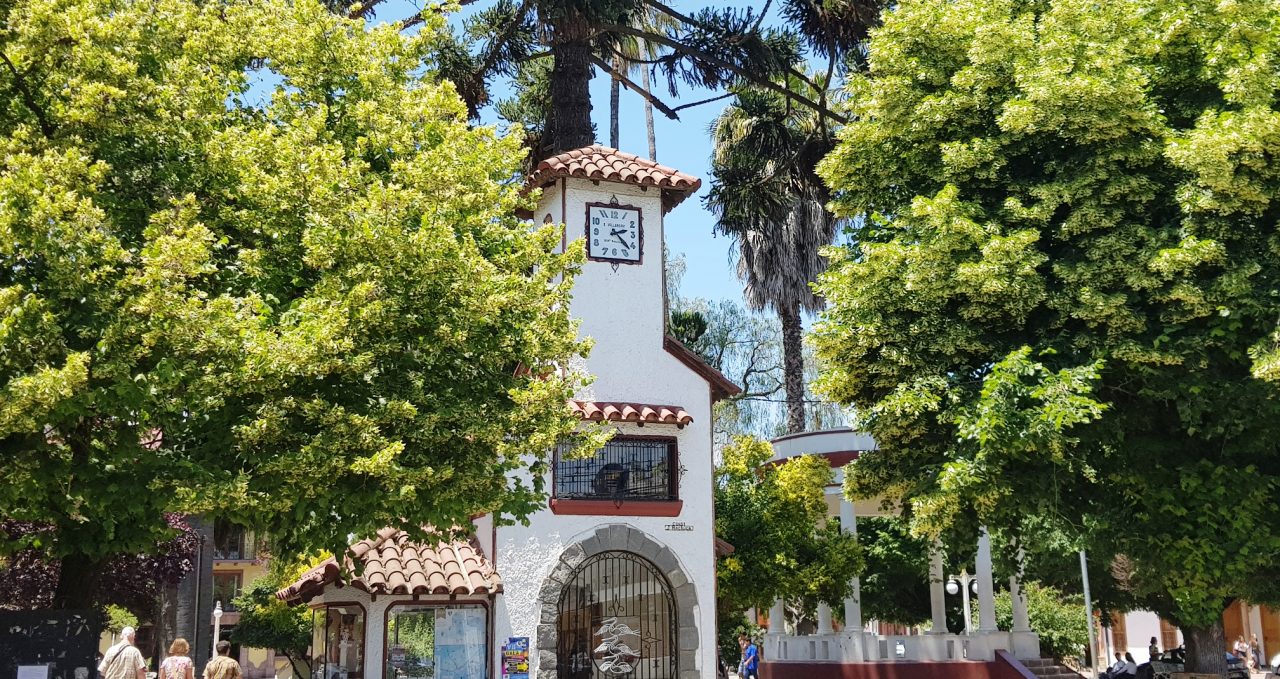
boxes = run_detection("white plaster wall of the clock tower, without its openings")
[495,179,716,675]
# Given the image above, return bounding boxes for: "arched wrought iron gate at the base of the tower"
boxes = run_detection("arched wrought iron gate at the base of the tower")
[556,552,678,679]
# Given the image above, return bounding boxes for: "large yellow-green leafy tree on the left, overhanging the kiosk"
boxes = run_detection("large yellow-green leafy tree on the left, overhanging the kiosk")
[0,0,585,607]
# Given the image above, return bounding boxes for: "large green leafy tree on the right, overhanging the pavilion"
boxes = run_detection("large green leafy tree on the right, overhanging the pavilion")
[815,0,1280,671]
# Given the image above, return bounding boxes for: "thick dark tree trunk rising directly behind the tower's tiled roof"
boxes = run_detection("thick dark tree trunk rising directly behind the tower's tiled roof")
[550,14,595,155]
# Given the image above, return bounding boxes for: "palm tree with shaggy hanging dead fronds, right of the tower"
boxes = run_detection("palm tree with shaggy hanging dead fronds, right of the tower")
[705,77,837,433]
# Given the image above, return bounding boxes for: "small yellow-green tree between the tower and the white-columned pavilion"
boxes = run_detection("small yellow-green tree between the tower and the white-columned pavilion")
[716,437,863,618]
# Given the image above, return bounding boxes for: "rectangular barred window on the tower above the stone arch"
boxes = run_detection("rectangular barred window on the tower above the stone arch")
[554,437,680,500]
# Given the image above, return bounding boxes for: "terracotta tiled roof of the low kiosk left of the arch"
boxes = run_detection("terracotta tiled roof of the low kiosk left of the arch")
[275,528,502,603]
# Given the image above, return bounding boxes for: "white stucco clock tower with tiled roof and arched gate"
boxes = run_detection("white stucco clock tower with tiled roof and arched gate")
[489,146,736,679]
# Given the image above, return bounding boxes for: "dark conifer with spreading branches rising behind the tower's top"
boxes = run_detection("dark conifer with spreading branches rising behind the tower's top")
[345,0,860,160]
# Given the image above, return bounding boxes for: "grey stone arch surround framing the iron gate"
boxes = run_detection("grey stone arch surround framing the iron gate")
[536,524,700,679]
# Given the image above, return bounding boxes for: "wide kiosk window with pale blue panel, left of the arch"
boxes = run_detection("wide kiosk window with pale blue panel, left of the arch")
[383,603,489,679]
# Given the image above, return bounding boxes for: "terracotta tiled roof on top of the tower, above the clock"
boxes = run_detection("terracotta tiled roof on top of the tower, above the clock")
[526,143,703,210]
